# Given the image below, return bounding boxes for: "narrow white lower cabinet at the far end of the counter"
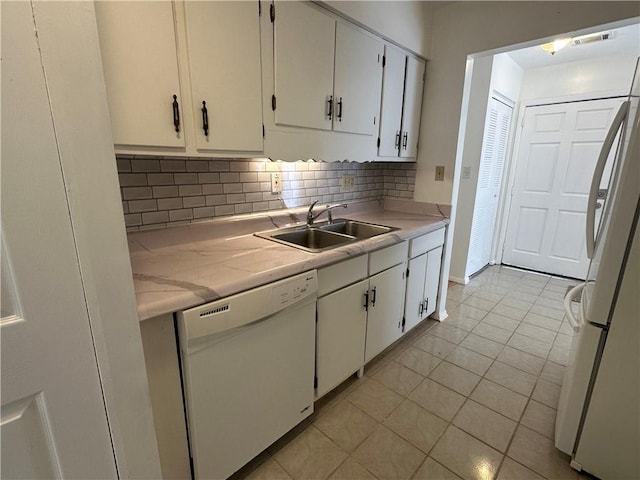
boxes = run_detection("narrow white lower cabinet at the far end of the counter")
[403,229,444,332]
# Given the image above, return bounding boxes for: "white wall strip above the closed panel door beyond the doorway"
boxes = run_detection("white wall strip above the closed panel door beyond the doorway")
[520,51,640,102]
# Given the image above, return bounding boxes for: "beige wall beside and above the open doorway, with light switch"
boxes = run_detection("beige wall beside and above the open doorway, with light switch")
[415,1,640,203]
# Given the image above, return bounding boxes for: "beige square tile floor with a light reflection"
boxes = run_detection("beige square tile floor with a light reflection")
[234,266,592,480]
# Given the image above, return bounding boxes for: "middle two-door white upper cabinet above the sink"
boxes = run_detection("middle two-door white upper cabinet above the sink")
[274,2,384,136]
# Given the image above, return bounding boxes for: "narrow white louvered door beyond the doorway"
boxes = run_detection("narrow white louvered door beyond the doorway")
[465,98,513,277]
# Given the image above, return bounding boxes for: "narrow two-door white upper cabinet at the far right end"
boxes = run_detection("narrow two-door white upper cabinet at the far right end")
[378,45,425,159]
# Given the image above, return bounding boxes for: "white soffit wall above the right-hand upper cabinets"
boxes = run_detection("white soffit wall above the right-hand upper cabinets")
[321,0,431,58]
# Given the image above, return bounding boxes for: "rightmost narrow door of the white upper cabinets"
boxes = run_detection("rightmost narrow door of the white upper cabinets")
[400,57,425,158]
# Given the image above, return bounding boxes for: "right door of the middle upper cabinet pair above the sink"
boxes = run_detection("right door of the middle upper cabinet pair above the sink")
[333,22,383,135]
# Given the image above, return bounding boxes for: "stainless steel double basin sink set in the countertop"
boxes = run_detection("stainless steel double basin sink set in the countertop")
[255,218,398,253]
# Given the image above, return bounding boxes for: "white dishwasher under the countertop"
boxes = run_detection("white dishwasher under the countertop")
[178,270,318,479]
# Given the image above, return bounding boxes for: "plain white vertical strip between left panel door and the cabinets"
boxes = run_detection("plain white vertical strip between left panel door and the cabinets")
[25,2,161,478]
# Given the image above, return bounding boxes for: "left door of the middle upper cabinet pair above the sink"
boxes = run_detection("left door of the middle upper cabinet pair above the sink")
[273,1,336,130]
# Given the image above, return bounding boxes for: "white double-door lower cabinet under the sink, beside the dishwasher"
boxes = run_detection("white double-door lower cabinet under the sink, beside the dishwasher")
[315,242,408,399]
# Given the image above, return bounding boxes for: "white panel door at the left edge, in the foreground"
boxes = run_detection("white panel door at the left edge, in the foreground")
[0,2,118,479]
